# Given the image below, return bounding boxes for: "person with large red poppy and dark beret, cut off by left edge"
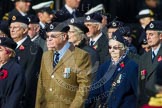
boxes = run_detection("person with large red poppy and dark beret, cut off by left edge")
[0,37,25,108]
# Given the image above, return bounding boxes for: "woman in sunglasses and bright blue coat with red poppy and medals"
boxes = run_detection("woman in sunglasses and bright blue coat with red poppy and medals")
[86,34,138,108]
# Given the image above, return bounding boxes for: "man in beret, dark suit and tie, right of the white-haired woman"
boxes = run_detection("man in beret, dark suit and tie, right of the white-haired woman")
[84,13,109,64]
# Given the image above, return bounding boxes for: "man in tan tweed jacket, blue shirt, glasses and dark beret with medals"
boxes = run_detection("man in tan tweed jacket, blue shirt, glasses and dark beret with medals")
[35,23,91,108]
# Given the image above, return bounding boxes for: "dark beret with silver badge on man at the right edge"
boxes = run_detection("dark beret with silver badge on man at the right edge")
[145,21,162,31]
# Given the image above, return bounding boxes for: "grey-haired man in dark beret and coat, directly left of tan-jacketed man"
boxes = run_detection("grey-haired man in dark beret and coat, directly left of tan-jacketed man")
[10,16,43,108]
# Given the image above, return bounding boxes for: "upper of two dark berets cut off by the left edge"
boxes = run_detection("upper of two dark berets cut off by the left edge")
[0,21,10,36]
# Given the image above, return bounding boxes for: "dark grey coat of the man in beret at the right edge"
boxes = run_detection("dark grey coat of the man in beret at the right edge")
[139,46,162,105]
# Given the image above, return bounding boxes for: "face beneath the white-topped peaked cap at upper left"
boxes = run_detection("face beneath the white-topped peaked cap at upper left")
[38,12,53,23]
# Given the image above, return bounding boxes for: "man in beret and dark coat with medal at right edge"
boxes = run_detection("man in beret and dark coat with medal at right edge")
[139,21,162,105]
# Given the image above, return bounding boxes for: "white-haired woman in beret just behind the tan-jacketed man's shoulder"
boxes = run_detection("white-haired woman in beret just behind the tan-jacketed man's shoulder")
[68,19,99,67]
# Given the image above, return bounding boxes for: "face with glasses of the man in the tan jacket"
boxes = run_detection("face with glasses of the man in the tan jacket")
[46,32,67,50]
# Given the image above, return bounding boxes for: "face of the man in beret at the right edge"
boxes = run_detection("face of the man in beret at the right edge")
[146,30,162,47]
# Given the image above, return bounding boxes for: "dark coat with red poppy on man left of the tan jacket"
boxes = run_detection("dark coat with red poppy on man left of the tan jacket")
[16,37,43,108]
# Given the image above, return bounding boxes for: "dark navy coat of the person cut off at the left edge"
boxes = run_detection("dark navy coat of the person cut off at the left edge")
[0,59,25,108]
